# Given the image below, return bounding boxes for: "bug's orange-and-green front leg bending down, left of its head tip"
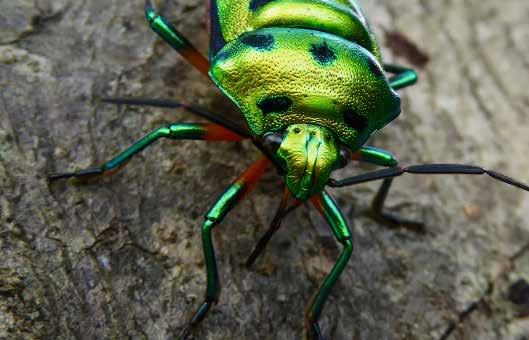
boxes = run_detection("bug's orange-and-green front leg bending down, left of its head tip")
[179,157,270,340]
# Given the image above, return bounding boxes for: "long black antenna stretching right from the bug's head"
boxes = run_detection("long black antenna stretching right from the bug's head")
[327,164,529,191]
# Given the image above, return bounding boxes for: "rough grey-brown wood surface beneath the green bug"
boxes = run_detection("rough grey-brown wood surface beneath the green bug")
[0,0,529,340]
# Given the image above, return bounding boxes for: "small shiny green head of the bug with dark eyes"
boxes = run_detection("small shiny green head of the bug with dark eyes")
[265,124,340,201]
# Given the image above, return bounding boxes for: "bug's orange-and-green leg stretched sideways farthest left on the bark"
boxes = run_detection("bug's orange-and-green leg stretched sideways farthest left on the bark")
[48,124,243,181]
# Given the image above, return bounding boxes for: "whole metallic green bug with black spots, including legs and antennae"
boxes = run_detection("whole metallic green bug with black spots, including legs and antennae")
[49,0,529,339]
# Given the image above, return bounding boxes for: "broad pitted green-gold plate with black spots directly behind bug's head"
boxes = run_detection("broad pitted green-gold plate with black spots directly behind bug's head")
[210,28,400,150]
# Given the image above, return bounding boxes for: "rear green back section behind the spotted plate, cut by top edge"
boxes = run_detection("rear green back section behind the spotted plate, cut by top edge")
[212,0,381,62]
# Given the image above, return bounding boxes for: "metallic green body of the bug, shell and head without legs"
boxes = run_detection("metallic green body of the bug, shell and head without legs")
[209,0,400,200]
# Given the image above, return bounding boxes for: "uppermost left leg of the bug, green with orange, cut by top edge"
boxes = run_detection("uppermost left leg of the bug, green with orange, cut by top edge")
[145,0,209,78]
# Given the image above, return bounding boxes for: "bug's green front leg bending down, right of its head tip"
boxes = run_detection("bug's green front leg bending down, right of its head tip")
[305,191,353,340]
